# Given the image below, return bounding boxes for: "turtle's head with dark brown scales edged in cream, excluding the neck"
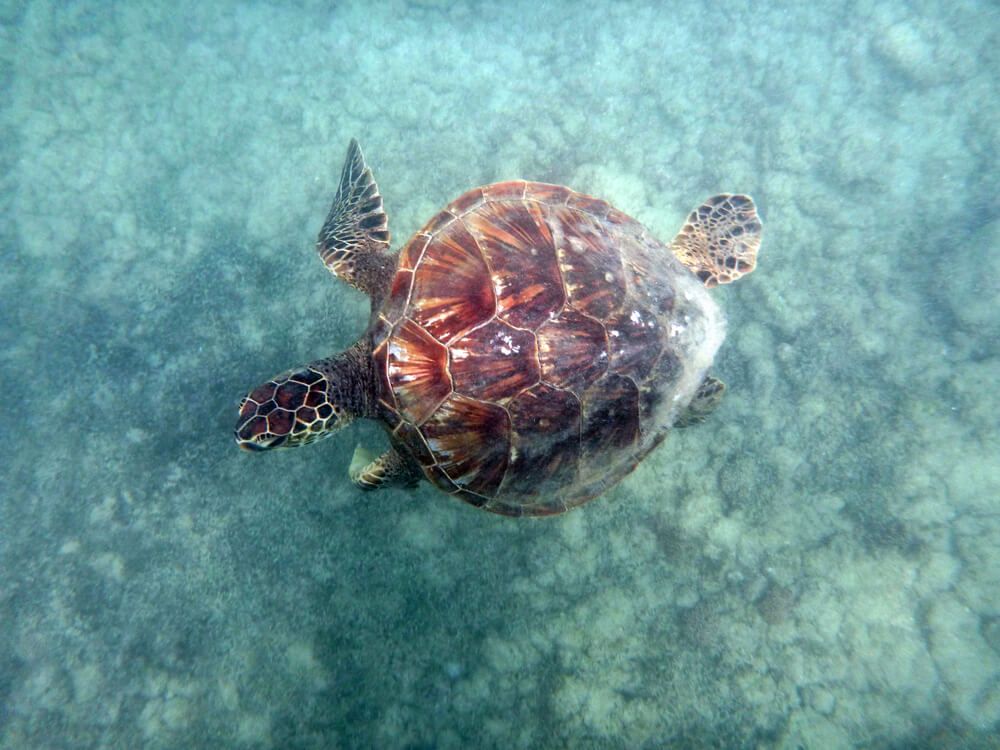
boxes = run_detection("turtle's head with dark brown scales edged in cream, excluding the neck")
[235,363,351,451]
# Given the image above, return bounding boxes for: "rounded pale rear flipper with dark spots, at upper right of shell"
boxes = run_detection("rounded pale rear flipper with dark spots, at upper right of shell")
[670,193,762,287]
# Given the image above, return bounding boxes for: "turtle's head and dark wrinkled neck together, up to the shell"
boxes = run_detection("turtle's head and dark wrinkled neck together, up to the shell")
[235,340,375,451]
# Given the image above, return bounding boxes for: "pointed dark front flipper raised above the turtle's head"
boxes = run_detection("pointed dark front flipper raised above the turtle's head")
[316,138,396,299]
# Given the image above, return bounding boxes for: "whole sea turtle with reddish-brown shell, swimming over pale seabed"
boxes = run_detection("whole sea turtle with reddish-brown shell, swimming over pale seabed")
[236,140,761,516]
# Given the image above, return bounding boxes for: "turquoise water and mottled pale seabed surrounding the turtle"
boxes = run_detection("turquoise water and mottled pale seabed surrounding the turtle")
[0,0,1000,748]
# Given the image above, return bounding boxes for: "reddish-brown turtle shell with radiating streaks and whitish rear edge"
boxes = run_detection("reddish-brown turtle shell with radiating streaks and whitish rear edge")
[369,181,724,515]
